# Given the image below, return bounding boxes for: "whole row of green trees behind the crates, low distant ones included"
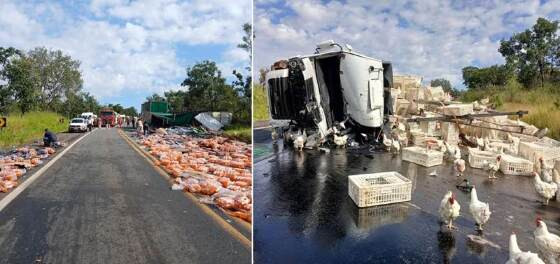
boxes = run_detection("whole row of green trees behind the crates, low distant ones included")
[462,18,560,89]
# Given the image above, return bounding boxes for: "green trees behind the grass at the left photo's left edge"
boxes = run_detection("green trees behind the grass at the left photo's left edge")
[0,47,100,117]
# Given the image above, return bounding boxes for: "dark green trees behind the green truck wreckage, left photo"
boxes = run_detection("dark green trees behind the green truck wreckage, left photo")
[146,23,253,124]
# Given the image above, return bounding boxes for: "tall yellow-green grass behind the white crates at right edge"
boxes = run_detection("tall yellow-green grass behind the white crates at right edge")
[461,81,560,140]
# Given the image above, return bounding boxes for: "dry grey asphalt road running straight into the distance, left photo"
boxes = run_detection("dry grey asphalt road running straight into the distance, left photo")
[0,129,251,263]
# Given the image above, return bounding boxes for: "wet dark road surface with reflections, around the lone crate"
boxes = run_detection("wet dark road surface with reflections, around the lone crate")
[254,130,560,263]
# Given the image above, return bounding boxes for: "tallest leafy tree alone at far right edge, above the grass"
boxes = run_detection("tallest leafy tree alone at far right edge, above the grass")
[498,18,560,87]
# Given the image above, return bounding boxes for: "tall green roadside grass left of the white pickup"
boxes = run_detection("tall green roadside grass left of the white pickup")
[0,112,68,148]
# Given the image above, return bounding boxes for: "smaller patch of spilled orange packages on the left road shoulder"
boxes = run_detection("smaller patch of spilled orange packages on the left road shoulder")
[0,146,56,193]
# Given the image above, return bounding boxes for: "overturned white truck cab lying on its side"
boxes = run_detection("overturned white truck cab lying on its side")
[266,41,393,146]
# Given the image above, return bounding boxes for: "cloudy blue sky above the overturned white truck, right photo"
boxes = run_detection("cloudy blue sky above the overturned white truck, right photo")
[254,0,560,87]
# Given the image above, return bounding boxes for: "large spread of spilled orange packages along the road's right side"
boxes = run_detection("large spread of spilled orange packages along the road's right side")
[138,127,253,222]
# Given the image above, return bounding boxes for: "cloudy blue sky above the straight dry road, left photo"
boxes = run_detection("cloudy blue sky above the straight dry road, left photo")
[0,0,252,109]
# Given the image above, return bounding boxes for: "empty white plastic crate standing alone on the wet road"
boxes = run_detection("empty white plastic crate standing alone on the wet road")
[348,171,412,207]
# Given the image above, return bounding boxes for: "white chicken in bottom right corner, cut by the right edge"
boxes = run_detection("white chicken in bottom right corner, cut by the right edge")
[533,217,560,264]
